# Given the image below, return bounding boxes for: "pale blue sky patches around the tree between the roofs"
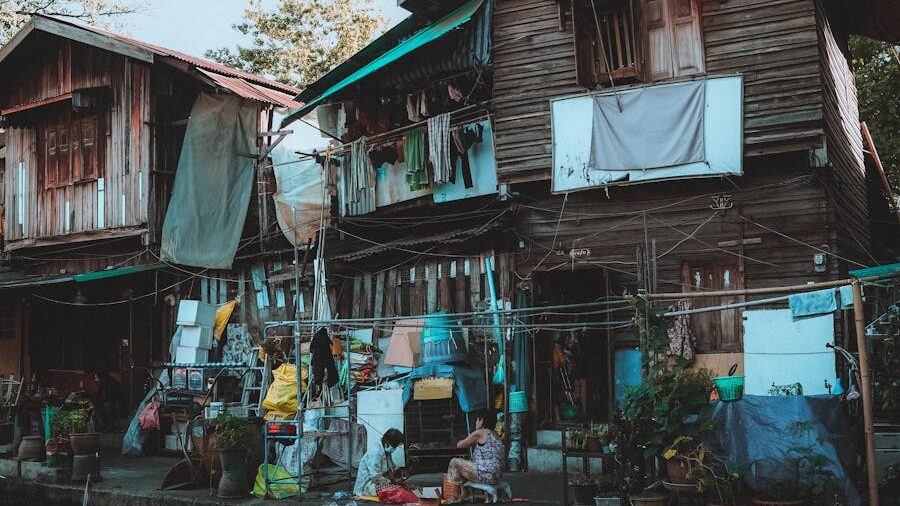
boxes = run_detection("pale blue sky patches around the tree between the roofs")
[124,0,409,56]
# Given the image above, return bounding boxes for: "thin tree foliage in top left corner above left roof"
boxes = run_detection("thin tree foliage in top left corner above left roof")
[0,0,141,45]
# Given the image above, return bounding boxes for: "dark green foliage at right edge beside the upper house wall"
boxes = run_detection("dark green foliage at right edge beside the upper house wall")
[850,36,900,189]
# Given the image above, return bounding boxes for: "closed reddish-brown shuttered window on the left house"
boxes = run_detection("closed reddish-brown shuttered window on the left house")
[38,111,105,188]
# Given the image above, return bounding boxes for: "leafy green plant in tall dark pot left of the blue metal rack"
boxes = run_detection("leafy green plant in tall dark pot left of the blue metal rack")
[215,411,247,497]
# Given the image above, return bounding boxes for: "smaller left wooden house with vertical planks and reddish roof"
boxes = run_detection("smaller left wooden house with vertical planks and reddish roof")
[0,16,298,404]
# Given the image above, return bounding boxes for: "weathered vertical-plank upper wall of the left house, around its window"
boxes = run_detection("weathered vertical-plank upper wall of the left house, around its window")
[4,42,150,243]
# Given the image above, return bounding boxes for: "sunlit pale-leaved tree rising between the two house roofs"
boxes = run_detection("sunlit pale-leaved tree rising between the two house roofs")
[206,0,384,88]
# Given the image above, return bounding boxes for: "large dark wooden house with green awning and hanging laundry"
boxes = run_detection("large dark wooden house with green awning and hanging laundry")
[278,0,898,468]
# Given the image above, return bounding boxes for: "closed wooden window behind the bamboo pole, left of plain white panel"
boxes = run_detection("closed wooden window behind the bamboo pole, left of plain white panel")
[682,259,744,352]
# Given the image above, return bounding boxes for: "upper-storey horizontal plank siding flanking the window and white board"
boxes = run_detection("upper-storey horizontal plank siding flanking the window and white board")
[493,0,824,182]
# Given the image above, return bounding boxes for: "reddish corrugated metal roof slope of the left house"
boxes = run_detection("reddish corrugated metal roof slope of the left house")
[29,15,300,107]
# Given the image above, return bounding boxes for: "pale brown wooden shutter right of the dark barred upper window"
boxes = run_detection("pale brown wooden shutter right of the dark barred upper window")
[643,0,704,81]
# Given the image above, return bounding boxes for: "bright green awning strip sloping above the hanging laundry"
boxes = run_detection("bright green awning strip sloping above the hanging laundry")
[281,0,484,128]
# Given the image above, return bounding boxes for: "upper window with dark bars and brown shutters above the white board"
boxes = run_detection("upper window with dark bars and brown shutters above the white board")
[572,0,704,89]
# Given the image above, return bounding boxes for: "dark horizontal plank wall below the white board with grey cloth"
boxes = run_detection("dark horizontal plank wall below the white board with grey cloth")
[517,164,838,295]
